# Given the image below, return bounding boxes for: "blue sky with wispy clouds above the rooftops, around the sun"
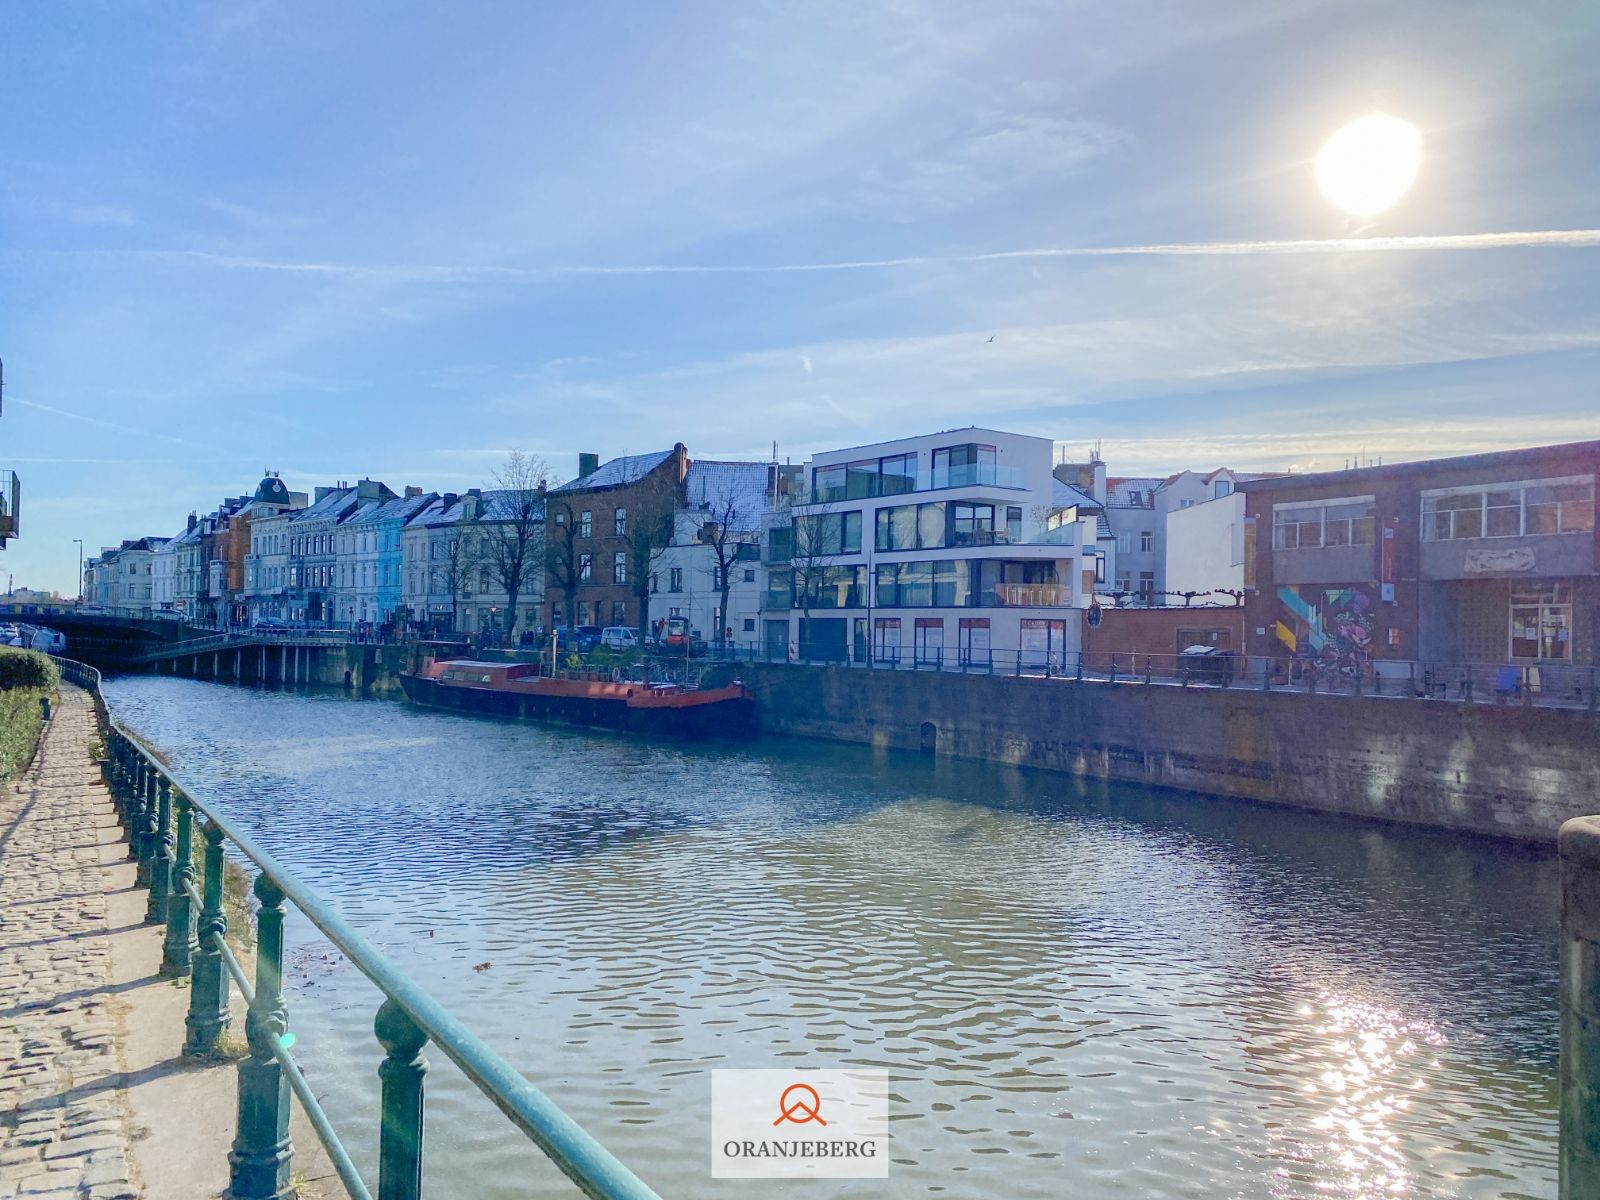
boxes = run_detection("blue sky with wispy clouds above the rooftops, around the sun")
[0,0,1600,594]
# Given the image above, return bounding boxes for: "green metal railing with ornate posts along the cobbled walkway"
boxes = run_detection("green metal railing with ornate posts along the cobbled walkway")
[54,658,659,1200]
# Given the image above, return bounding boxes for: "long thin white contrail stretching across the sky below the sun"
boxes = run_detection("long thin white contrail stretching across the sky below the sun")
[130,229,1600,283]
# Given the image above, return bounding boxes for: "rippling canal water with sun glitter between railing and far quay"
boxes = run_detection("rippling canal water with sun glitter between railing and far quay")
[96,677,1558,1200]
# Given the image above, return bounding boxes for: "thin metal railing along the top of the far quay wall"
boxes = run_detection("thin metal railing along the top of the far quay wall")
[691,642,1600,712]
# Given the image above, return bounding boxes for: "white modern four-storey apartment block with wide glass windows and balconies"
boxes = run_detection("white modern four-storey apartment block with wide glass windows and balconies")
[777,427,1096,669]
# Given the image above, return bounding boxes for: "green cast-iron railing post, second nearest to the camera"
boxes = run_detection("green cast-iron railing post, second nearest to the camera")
[227,874,294,1200]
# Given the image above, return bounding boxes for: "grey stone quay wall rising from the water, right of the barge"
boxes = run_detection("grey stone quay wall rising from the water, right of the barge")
[733,662,1600,848]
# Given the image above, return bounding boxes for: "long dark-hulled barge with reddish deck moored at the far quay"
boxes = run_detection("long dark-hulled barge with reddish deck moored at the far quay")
[400,659,755,738]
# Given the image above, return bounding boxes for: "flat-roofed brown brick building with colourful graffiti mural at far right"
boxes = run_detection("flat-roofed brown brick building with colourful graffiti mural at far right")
[1238,442,1600,677]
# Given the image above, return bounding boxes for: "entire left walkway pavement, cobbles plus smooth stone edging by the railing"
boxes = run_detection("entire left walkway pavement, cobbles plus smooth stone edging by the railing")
[0,683,338,1200]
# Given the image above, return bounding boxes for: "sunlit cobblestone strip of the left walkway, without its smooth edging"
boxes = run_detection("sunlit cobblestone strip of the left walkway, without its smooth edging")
[0,683,139,1200]
